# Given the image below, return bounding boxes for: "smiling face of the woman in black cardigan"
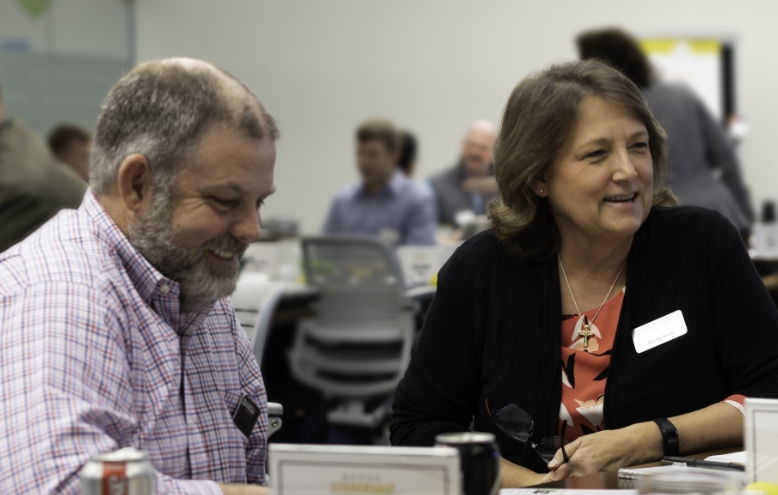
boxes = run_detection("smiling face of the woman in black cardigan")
[534,97,654,247]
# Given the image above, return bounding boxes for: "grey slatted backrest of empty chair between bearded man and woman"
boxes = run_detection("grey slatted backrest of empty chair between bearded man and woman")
[290,237,413,398]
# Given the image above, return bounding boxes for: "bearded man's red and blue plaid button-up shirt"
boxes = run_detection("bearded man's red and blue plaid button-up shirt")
[0,191,267,494]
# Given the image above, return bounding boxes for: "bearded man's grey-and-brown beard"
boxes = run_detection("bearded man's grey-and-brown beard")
[128,193,248,313]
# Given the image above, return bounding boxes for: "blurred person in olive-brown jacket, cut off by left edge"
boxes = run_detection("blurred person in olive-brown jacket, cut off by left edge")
[0,83,87,252]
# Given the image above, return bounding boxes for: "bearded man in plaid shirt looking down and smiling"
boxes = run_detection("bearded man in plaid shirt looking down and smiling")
[0,59,278,494]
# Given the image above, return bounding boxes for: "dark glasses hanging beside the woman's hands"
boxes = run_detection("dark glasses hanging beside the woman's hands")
[486,378,570,464]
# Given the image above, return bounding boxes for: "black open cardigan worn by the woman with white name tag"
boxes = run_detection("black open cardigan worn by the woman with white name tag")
[391,207,778,471]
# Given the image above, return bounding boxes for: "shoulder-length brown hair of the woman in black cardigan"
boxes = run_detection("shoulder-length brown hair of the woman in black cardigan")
[489,60,676,259]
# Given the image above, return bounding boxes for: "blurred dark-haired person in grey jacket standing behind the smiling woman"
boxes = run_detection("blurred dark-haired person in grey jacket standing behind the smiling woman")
[576,28,754,234]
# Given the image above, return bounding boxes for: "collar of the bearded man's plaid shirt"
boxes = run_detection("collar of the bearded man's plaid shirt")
[81,188,179,304]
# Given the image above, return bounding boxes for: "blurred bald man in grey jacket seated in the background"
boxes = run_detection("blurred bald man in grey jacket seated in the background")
[430,120,498,225]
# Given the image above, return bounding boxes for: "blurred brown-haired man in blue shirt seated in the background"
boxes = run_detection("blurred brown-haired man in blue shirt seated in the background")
[323,119,436,245]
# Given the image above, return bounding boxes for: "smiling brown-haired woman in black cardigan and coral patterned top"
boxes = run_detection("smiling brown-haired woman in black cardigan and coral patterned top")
[391,61,778,486]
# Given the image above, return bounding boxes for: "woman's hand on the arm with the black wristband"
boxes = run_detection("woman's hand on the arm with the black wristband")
[548,422,662,479]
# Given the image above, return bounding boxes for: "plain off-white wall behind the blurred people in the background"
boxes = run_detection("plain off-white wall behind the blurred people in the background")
[137,0,778,232]
